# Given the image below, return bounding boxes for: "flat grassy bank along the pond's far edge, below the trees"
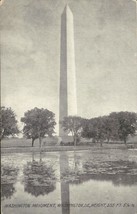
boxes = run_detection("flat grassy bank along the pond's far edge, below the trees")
[1,138,137,153]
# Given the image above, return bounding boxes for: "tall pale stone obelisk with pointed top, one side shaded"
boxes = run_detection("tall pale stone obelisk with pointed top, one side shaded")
[59,5,77,136]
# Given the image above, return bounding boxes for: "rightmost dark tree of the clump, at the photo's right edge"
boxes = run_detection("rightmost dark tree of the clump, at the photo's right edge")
[110,112,137,144]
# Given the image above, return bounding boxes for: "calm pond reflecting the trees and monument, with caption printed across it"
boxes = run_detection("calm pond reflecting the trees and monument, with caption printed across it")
[1,149,137,214]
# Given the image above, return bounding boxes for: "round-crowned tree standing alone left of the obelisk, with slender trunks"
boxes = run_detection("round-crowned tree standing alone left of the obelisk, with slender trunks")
[21,108,56,147]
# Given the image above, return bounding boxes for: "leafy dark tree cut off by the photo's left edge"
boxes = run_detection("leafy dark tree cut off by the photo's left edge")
[0,107,19,139]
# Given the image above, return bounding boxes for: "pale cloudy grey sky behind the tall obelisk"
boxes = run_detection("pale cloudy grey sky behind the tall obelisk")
[0,0,137,133]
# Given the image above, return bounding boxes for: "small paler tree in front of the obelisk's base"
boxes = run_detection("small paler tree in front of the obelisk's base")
[61,116,83,146]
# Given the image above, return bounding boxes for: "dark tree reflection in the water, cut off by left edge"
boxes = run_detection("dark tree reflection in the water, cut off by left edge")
[1,165,19,200]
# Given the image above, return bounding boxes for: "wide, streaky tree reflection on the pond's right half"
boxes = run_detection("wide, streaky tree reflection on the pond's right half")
[61,153,137,186]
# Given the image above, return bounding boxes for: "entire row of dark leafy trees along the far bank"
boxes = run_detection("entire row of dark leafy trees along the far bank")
[0,107,137,146]
